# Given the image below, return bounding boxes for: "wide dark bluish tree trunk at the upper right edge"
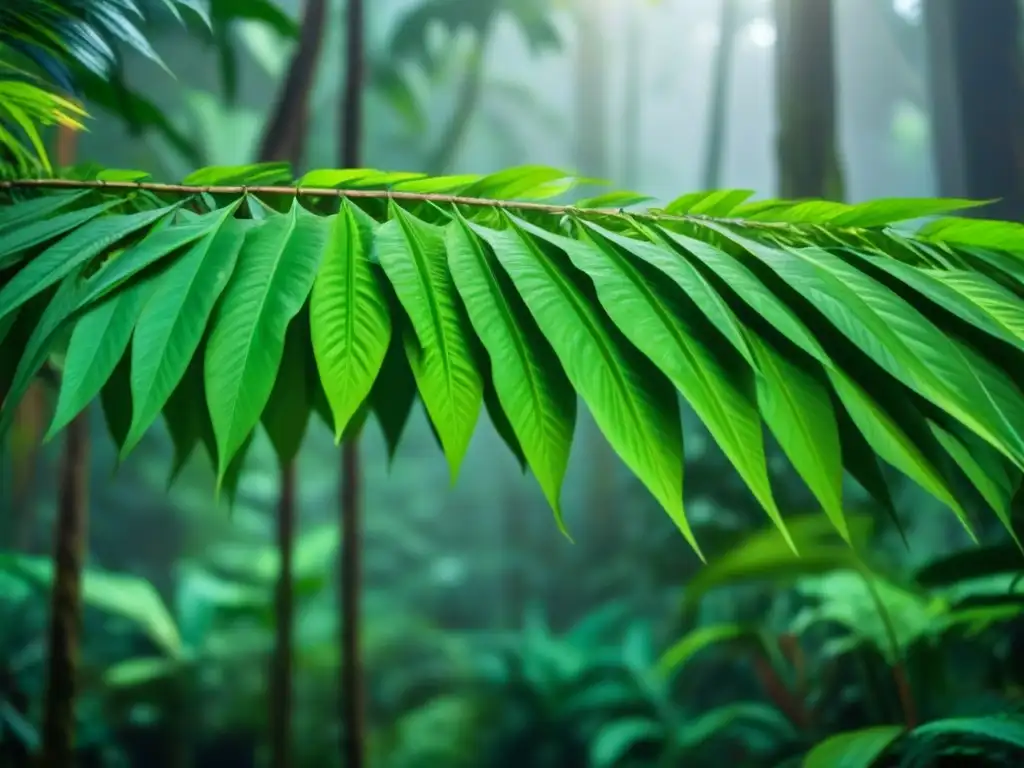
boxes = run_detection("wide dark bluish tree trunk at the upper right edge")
[923,0,1024,220]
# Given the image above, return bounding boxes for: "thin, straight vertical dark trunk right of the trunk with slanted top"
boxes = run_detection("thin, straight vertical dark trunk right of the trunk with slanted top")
[338,0,367,768]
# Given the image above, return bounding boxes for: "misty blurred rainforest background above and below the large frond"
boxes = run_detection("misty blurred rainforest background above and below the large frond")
[0,0,1024,768]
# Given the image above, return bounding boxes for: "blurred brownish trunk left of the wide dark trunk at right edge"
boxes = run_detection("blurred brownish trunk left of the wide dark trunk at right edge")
[775,0,843,200]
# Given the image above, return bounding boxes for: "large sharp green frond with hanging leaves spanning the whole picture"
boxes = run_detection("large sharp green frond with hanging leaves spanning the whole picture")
[0,164,1024,552]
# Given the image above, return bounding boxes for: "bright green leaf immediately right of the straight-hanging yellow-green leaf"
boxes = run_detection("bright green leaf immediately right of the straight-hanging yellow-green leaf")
[377,206,483,482]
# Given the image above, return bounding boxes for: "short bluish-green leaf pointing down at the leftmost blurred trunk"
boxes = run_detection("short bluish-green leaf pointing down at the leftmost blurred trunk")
[44,280,154,440]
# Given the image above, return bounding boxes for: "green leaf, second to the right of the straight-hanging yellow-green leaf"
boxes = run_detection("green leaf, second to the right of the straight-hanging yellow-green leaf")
[445,217,577,524]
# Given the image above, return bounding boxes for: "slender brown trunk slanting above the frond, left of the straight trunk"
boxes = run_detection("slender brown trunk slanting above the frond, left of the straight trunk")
[259,0,327,768]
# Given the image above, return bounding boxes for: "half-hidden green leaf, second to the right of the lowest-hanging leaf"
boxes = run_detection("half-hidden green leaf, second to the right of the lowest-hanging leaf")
[748,333,850,545]
